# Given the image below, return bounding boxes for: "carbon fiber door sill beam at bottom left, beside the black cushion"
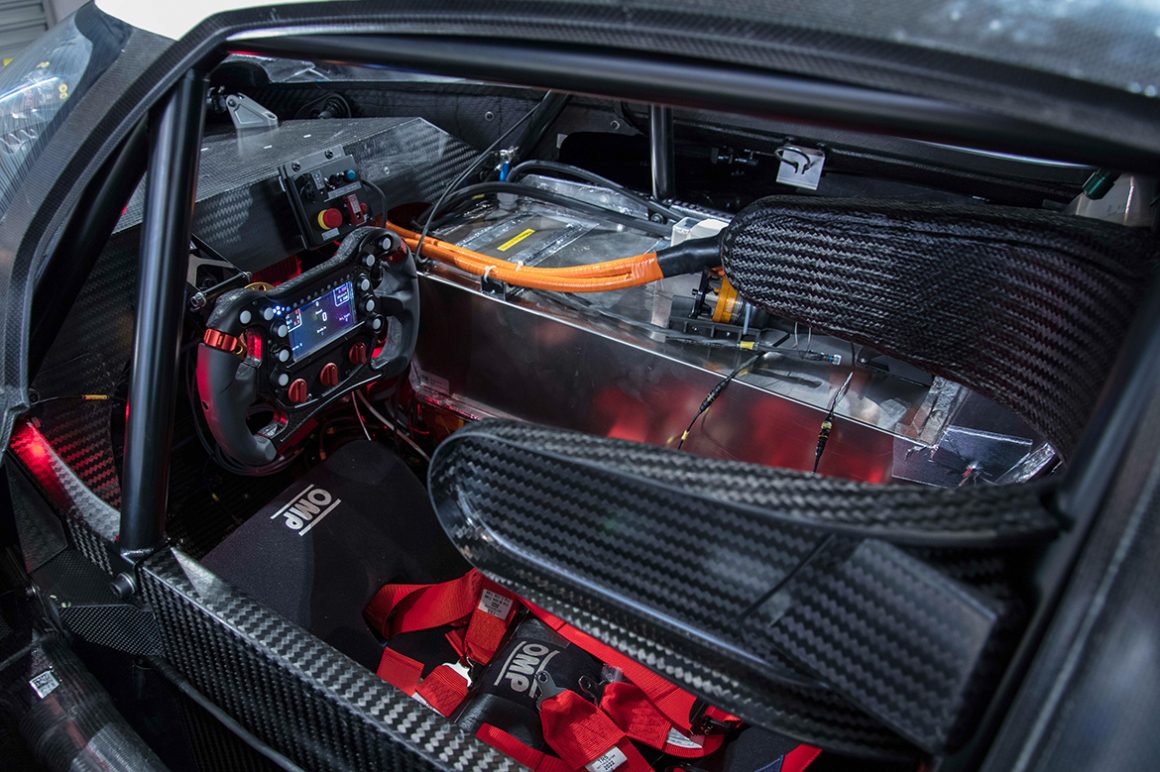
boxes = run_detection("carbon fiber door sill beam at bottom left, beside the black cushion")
[140,549,517,770]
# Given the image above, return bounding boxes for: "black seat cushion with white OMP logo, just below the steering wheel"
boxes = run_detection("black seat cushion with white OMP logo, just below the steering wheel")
[202,442,469,670]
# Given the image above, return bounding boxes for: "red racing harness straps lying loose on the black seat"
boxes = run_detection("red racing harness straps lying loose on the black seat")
[364,569,815,772]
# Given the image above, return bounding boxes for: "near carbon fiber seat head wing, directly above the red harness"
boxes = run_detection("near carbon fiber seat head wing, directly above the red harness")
[429,421,1054,756]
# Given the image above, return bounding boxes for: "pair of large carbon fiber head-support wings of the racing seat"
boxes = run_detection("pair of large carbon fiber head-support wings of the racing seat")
[429,198,1152,757]
